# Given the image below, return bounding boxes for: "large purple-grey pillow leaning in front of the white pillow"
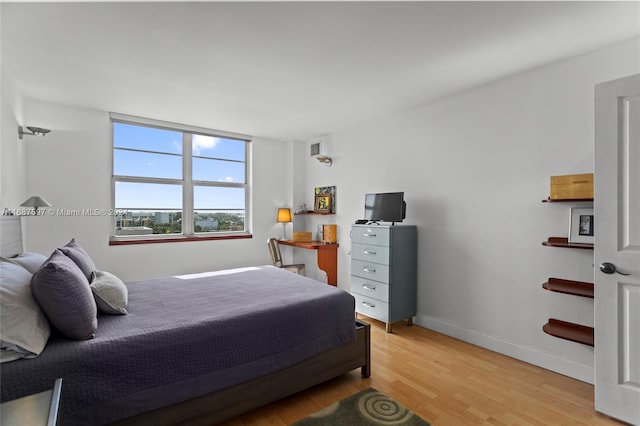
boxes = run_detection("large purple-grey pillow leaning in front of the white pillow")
[31,249,98,340]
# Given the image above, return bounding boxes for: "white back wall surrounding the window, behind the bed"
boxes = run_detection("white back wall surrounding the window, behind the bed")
[13,100,292,280]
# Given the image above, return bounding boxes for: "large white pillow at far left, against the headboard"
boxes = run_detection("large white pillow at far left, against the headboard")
[0,262,51,362]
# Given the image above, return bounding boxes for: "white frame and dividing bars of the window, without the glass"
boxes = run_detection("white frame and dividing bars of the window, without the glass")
[109,112,252,243]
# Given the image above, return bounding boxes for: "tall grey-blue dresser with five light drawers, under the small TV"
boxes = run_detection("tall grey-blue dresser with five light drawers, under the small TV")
[351,225,417,333]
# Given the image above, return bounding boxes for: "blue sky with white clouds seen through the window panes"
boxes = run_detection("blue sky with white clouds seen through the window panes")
[114,123,245,211]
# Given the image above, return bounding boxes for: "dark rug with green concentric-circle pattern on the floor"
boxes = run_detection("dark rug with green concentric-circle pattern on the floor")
[293,388,429,426]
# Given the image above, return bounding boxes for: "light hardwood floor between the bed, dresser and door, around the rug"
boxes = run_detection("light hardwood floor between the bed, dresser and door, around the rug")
[225,317,622,426]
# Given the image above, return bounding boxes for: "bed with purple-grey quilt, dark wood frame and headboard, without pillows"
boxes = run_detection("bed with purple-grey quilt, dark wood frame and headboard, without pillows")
[0,217,370,425]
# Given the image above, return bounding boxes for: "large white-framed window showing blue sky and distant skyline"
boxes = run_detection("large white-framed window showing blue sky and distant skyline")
[111,114,251,242]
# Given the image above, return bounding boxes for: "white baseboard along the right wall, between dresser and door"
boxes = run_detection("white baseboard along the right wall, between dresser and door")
[414,315,594,384]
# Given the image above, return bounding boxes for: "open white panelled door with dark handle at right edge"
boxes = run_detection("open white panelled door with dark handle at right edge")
[594,74,640,425]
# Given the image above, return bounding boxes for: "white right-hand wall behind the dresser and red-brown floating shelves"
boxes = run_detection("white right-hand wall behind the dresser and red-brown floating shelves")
[300,39,640,382]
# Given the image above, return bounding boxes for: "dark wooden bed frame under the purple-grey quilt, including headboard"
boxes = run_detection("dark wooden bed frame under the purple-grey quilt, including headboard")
[0,216,371,426]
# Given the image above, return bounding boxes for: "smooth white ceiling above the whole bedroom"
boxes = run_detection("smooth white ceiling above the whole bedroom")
[0,1,640,140]
